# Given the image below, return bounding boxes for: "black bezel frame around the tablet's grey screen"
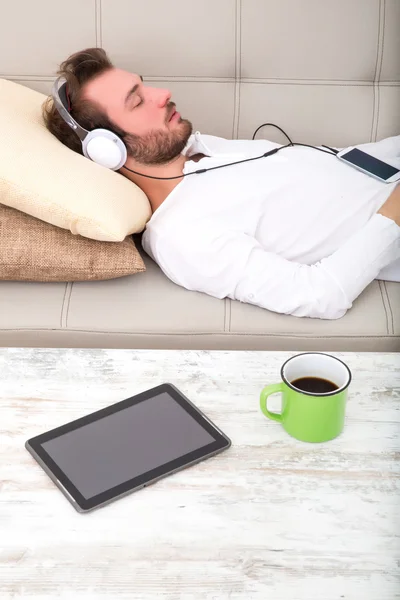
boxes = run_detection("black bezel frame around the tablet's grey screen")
[25,383,231,512]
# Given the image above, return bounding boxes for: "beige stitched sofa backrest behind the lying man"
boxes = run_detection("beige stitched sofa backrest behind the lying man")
[0,0,400,147]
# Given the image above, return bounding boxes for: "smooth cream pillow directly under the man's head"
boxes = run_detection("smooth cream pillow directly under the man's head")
[0,79,151,242]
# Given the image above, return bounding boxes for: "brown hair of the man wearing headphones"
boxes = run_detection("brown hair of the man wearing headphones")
[43,48,127,154]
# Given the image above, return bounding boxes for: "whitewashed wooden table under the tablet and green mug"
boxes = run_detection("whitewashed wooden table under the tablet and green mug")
[0,349,400,600]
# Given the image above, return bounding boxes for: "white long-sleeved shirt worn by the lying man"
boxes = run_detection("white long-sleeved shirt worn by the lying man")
[142,132,400,319]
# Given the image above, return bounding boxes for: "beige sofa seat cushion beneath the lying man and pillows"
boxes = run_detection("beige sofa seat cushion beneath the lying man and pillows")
[0,250,400,351]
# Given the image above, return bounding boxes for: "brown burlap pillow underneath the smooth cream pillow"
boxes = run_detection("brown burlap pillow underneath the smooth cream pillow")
[0,198,145,281]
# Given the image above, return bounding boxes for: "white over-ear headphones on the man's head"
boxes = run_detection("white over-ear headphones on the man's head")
[52,77,127,171]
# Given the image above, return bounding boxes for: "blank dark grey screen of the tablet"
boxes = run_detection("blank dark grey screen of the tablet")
[42,392,215,499]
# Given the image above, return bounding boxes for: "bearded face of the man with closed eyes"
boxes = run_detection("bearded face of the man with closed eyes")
[83,68,193,165]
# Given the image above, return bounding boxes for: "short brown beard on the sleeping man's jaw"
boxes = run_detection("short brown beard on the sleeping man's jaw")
[124,119,193,165]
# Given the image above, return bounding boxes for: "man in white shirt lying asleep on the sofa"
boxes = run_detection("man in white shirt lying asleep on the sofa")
[44,48,400,319]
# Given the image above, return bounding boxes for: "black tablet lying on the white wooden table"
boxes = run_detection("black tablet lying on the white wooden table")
[25,383,231,512]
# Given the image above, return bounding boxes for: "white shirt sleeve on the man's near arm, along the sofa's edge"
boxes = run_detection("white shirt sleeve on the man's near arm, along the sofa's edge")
[154,214,400,319]
